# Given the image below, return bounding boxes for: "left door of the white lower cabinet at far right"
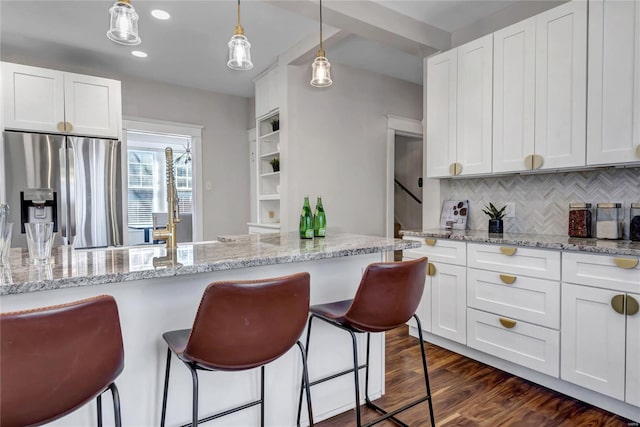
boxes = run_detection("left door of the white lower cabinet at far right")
[560,283,626,400]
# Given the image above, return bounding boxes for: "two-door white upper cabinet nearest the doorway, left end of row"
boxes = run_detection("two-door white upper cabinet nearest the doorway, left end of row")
[426,34,493,178]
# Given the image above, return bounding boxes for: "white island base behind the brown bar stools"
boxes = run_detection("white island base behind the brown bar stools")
[0,253,384,427]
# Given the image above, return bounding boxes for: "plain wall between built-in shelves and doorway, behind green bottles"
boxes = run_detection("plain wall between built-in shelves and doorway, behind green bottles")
[281,63,422,235]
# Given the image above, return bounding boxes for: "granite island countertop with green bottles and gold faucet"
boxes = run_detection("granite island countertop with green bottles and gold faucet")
[0,233,420,295]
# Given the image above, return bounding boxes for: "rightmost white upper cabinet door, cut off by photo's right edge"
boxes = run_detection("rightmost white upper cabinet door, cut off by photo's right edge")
[587,0,640,165]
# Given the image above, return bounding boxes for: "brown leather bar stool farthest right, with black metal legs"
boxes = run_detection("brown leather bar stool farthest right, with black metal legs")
[298,257,435,427]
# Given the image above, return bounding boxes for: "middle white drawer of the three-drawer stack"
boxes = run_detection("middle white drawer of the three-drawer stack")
[467,268,560,329]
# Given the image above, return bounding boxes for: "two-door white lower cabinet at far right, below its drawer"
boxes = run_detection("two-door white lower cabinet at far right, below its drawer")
[561,283,640,406]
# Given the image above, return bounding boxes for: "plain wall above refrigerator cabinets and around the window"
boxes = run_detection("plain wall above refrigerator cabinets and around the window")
[2,53,250,240]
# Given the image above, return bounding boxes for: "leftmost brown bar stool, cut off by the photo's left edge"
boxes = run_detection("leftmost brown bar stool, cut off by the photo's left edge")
[0,295,124,427]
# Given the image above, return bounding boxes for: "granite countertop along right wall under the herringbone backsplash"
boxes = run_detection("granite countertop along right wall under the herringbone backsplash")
[400,229,640,257]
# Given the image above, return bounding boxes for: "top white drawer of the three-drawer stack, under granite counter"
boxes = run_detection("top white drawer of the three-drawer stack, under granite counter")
[467,243,560,280]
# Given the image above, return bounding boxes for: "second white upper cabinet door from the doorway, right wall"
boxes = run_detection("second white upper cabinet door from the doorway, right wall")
[456,34,493,175]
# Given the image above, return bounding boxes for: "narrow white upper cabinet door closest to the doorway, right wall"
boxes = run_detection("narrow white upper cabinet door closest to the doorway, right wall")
[425,49,458,178]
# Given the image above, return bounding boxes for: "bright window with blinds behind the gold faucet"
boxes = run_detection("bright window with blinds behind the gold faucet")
[127,131,193,228]
